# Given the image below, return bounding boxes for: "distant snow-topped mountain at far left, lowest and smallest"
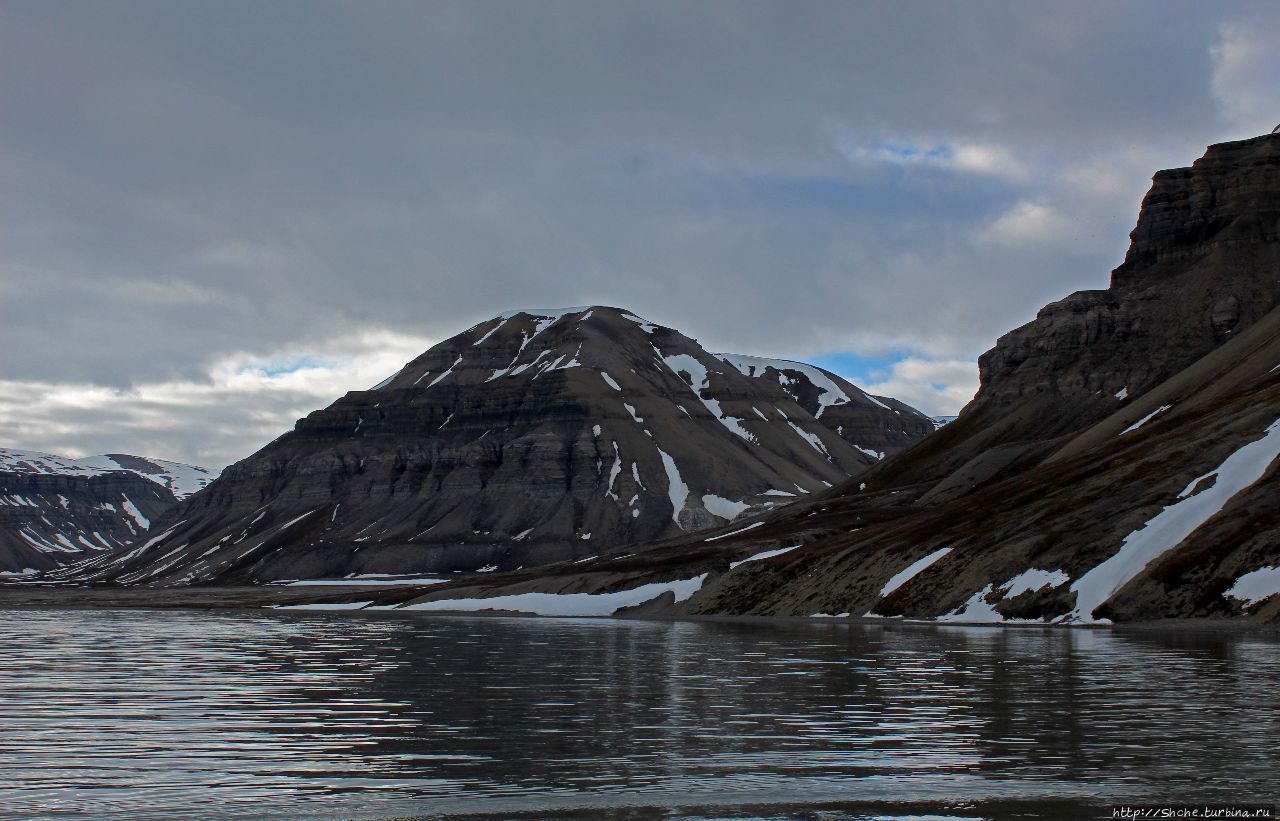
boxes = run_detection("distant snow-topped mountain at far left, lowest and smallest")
[0,448,215,578]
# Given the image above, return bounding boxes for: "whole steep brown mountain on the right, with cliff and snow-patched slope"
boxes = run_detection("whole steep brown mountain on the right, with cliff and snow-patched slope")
[317,137,1280,624]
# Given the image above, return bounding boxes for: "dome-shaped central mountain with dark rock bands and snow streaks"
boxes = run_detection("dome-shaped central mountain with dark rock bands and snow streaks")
[67,306,934,584]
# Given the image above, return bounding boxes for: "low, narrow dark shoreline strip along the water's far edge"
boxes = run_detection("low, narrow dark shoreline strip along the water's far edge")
[0,584,1280,634]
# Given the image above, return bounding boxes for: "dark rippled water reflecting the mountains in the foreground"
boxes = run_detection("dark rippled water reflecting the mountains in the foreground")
[0,610,1280,818]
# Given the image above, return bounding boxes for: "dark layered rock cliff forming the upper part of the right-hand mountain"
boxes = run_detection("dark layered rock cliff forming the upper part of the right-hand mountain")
[860,136,1280,482]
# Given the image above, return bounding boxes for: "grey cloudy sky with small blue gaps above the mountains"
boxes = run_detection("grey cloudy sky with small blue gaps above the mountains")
[0,0,1280,467]
